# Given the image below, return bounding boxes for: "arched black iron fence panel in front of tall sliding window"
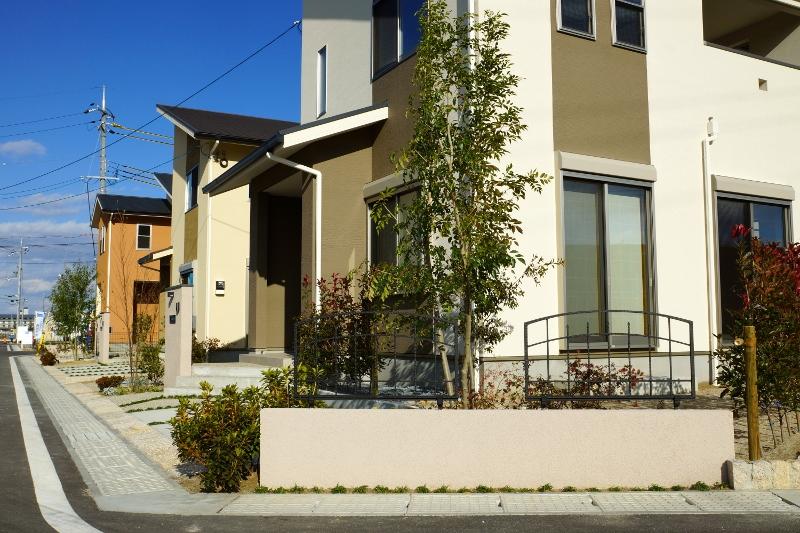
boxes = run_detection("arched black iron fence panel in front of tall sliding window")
[524,310,696,408]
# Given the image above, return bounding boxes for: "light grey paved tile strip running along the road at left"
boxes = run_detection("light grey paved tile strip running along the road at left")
[18,357,174,496]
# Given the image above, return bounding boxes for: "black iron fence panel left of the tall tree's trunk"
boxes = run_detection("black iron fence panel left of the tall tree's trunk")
[293,311,460,404]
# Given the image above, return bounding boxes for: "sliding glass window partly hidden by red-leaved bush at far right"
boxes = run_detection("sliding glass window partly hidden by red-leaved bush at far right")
[717,193,789,341]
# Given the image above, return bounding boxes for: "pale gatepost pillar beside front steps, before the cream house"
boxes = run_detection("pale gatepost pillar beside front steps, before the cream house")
[164,285,192,390]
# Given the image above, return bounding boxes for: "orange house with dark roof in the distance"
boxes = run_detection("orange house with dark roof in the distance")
[92,194,172,345]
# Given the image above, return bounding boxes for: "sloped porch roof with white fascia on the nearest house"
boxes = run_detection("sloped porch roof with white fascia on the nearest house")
[203,103,389,196]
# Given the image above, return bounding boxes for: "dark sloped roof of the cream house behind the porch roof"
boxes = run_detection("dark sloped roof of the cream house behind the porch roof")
[156,104,297,146]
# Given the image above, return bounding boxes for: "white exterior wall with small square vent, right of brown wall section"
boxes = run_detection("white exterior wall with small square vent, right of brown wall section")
[647,0,800,360]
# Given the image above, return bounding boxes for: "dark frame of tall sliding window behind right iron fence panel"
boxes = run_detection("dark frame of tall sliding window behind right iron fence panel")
[559,170,659,350]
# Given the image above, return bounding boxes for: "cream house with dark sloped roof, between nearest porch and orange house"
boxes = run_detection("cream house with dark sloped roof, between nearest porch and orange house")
[156,105,294,348]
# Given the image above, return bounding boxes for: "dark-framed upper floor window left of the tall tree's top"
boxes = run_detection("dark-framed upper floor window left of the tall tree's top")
[372,0,425,76]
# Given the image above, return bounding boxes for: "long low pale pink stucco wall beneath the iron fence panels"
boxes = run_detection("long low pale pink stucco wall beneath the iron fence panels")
[260,409,734,488]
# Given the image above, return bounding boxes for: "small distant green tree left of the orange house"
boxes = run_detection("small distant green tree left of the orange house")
[50,265,95,357]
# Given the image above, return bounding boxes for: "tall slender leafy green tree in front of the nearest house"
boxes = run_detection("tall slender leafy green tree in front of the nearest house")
[373,0,555,407]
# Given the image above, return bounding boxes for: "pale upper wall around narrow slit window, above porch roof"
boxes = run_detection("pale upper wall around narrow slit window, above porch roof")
[300,0,372,124]
